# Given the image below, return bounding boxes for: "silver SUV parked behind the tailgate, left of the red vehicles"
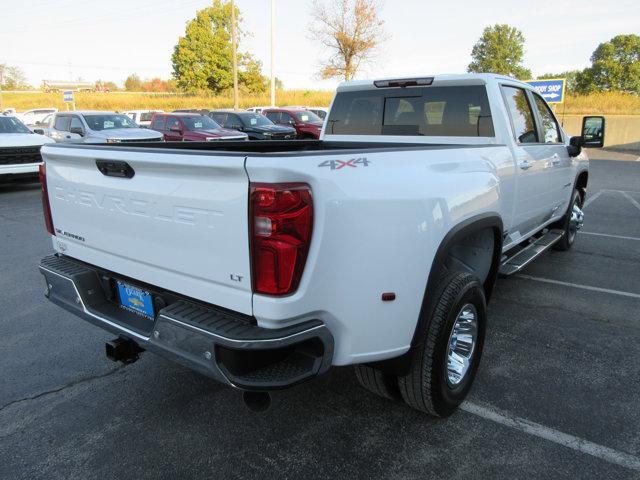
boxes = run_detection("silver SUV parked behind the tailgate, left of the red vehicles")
[48,111,163,143]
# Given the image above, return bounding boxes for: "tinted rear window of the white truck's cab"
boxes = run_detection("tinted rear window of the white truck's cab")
[326,85,495,137]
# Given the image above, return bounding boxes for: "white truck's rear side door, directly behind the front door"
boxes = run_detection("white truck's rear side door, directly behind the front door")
[501,85,554,241]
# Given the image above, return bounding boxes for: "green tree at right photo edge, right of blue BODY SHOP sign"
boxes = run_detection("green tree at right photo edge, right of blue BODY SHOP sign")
[580,34,640,93]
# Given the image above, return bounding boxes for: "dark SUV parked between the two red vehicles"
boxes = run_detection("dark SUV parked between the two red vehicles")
[209,110,297,140]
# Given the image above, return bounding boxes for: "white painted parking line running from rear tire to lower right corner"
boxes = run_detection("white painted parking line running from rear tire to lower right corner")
[460,402,640,471]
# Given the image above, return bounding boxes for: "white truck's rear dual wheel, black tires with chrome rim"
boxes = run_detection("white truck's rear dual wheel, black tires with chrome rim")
[398,273,487,417]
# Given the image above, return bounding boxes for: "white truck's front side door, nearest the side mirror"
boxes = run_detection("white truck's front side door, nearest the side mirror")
[531,92,574,216]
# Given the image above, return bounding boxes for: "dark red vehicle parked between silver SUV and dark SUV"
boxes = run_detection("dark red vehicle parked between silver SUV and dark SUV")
[149,113,248,142]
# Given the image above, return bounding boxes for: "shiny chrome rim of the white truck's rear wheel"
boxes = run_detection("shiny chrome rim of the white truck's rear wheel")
[445,303,478,387]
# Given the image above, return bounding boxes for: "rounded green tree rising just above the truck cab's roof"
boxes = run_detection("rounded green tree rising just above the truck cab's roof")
[467,24,531,80]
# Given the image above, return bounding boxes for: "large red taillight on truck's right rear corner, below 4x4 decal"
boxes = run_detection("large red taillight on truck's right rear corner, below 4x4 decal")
[249,183,313,295]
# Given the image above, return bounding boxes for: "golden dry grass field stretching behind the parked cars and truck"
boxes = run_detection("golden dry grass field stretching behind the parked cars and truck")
[3,90,640,115]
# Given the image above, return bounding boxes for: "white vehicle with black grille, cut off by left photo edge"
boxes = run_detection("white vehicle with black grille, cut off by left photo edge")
[0,115,54,179]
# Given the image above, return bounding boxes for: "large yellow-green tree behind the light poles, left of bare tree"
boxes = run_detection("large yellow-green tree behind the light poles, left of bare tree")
[171,0,264,93]
